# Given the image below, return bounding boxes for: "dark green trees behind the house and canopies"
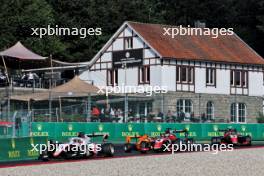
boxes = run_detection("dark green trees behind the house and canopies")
[0,0,264,62]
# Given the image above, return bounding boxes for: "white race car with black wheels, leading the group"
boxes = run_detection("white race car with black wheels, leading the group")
[39,132,115,161]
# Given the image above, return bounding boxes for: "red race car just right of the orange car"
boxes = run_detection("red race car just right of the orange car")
[153,128,193,151]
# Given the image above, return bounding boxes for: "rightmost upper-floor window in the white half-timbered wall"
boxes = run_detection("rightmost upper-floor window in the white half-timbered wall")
[230,70,248,88]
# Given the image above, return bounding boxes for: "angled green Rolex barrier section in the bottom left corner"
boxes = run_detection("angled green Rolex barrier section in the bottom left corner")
[0,137,47,162]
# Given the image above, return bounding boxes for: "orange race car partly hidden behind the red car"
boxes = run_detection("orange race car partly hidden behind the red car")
[124,134,154,153]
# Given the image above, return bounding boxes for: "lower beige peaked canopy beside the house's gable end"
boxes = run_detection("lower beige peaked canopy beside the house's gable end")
[11,76,99,101]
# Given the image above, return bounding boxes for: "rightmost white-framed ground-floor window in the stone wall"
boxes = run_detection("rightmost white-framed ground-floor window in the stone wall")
[230,103,246,123]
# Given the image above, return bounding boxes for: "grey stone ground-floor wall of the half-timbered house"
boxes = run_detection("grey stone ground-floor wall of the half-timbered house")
[153,92,263,123]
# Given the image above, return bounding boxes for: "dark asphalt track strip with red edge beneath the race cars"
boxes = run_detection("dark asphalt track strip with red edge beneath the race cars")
[0,142,264,169]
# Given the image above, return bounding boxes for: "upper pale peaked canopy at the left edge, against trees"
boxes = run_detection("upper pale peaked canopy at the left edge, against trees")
[0,42,46,60]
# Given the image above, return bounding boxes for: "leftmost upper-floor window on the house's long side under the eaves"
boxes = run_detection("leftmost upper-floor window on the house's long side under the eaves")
[176,66,194,84]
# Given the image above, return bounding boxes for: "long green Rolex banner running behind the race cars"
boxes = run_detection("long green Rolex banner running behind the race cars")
[31,122,264,142]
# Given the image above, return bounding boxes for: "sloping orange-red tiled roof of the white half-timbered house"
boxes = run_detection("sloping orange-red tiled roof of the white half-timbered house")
[127,22,264,65]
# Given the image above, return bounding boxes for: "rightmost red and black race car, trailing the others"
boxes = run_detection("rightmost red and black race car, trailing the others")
[211,129,252,146]
